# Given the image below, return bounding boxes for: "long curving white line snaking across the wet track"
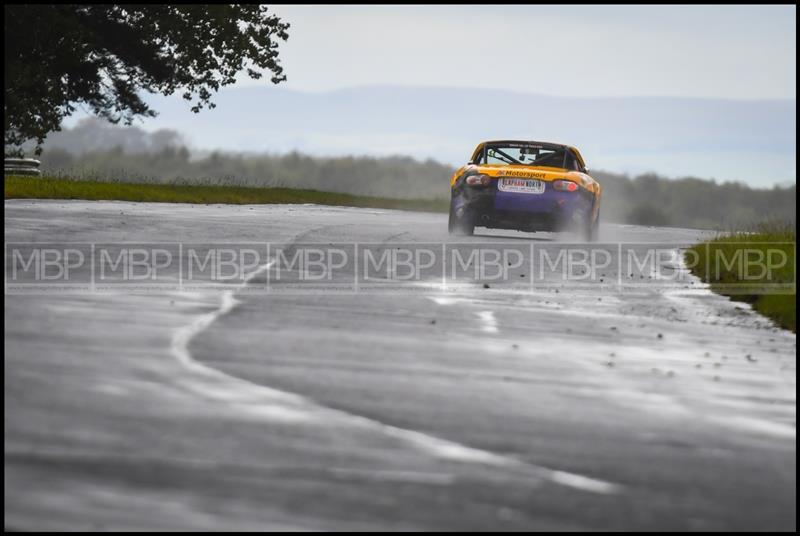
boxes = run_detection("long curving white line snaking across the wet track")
[171,261,620,494]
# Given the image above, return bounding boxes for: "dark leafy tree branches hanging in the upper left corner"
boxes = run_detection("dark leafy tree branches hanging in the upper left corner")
[4,4,289,154]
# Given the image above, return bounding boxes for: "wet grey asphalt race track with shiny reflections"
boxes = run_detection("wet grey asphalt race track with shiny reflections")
[5,201,796,530]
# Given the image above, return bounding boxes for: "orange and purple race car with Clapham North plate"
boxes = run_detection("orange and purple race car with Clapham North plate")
[448,141,601,241]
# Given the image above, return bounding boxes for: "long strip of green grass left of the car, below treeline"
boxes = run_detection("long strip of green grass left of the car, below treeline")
[5,176,448,212]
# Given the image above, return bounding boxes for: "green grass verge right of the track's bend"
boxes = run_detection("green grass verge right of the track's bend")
[686,224,797,332]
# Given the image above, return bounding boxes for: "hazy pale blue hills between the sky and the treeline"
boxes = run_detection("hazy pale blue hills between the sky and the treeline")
[56,86,796,186]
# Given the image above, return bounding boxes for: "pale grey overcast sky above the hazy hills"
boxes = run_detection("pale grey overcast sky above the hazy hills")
[264,5,797,99]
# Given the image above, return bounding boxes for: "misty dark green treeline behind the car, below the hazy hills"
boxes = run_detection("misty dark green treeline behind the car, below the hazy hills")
[29,120,796,229]
